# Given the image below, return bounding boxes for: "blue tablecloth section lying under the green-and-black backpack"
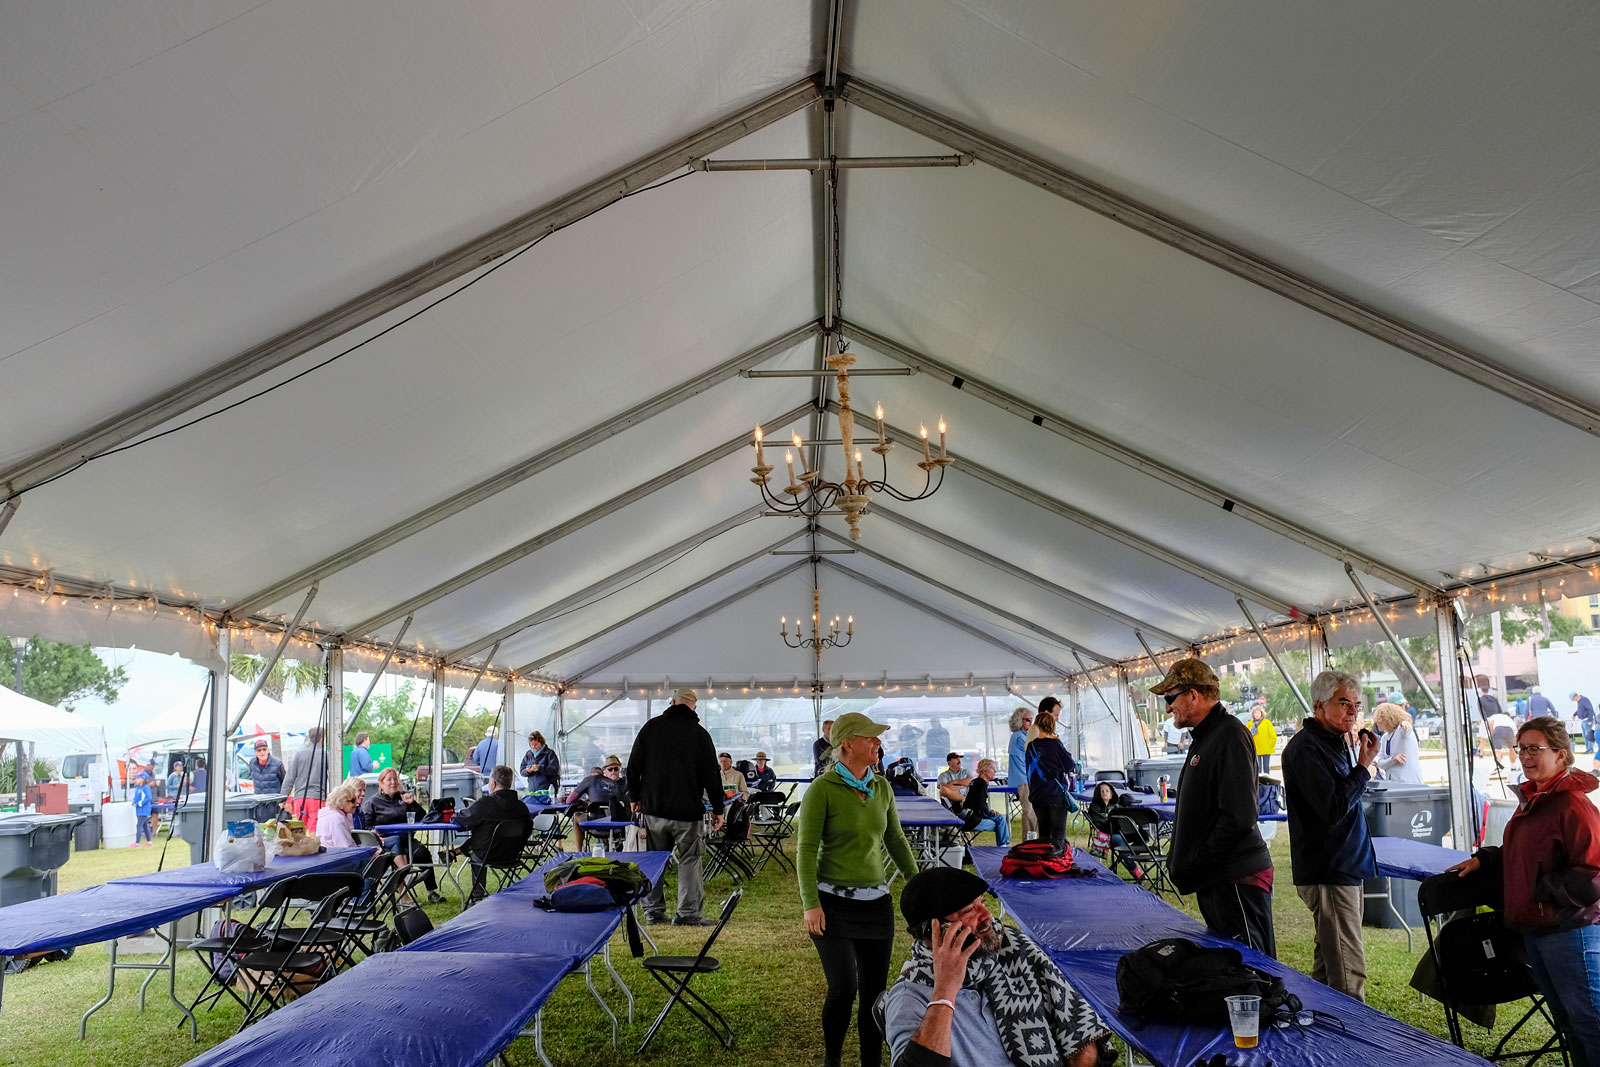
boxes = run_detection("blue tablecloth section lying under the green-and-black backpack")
[400,853,669,961]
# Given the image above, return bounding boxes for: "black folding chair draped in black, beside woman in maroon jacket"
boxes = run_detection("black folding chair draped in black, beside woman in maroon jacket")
[1416,872,1568,1064]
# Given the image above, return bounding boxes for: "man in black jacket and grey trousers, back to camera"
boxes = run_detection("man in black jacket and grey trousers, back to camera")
[627,689,723,926]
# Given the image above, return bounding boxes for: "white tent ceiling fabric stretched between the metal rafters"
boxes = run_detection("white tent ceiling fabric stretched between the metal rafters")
[0,0,1600,685]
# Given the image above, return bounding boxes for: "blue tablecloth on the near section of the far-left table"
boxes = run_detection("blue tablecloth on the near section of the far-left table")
[0,881,238,955]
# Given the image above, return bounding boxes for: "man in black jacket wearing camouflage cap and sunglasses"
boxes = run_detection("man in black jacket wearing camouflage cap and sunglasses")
[1150,659,1277,957]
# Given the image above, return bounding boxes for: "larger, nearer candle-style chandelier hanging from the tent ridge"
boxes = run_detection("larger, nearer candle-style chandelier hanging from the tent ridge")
[750,342,950,537]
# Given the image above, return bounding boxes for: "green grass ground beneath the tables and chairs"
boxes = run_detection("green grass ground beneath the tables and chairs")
[0,827,1542,1067]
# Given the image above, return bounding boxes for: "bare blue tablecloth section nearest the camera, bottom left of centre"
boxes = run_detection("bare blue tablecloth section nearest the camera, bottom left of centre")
[180,945,574,1067]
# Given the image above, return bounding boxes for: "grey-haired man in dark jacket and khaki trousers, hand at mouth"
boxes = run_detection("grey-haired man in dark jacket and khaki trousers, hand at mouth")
[1283,670,1378,1000]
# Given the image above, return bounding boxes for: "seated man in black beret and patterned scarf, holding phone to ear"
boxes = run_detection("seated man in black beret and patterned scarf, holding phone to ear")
[883,867,1115,1067]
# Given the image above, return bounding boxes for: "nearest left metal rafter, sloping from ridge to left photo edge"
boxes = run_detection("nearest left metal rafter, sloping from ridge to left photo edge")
[0,77,821,493]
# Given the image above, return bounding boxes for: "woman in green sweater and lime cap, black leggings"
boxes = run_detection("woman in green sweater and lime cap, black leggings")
[795,712,917,1067]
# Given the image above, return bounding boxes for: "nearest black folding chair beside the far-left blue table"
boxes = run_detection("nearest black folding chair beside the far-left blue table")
[235,875,362,1030]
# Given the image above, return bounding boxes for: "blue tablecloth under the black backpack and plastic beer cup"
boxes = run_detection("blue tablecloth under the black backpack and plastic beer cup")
[971,846,1485,1067]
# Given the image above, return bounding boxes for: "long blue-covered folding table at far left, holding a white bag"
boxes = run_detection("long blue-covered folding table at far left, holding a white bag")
[0,848,374,1040]
